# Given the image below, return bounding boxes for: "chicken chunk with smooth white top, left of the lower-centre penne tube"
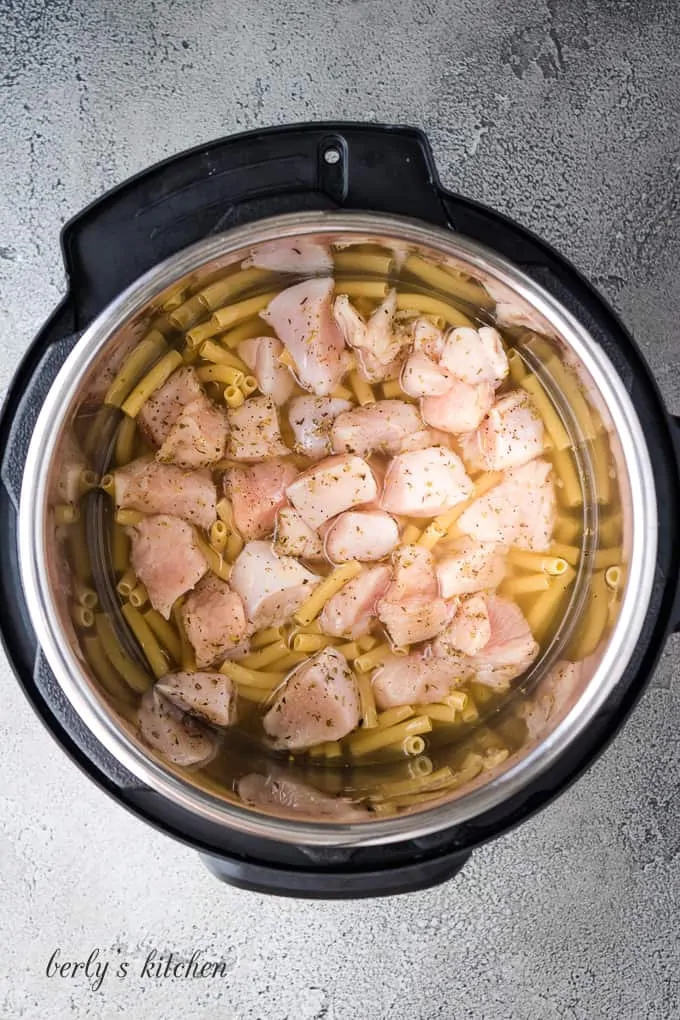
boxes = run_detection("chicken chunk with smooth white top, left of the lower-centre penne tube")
[229,542,321,628]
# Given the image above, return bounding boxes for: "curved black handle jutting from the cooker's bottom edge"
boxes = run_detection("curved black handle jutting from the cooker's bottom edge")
[200,852,470,900]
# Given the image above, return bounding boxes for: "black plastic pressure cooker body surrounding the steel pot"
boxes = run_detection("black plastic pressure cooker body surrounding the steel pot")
[0,123,680,898]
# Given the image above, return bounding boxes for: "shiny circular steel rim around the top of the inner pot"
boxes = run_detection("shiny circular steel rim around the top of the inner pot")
[18,212,658,847]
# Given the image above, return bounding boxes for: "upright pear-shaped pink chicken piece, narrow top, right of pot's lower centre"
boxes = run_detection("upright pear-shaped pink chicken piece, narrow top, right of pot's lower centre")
[377,546,456,647]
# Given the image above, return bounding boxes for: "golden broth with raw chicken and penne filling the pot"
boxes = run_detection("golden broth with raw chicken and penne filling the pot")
[54,234,625,817]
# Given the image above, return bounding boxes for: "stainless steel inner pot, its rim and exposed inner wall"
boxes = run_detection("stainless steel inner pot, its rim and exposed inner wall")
[18,212,658,846]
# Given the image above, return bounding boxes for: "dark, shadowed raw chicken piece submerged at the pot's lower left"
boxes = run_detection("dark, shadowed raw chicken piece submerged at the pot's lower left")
[137,686,217,767]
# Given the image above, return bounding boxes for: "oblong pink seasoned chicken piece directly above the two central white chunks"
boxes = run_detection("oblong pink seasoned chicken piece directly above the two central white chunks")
[330,400,421,457]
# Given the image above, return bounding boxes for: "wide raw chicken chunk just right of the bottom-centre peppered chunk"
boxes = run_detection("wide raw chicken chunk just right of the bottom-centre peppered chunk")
[373,655,460,711]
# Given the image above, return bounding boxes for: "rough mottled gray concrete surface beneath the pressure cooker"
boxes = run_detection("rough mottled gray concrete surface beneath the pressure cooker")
[0,0,680,1020]
